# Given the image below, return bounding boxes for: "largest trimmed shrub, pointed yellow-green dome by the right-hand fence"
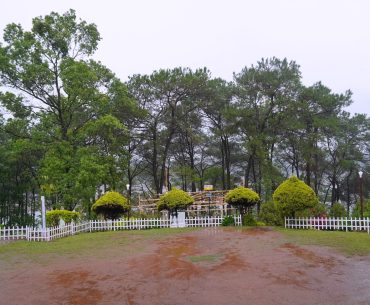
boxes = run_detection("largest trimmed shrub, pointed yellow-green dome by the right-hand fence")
[273,176,319,217]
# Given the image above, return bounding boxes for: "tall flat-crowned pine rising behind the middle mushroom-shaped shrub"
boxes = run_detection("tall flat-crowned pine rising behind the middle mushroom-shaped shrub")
[128,68,209,194]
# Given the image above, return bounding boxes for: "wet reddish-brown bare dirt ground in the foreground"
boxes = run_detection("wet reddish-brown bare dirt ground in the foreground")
[0,228,370,305]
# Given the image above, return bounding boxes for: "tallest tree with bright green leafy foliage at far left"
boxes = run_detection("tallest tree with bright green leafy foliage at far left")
[0,10,138,223]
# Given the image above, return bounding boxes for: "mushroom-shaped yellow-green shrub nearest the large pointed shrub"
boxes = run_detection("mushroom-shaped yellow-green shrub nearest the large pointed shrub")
[225,186,260,215]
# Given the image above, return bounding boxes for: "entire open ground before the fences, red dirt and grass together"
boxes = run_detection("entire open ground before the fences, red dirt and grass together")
[0,227,370,305]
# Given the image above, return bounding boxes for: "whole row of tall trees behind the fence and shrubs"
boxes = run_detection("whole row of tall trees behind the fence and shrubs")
[0,10,370,224]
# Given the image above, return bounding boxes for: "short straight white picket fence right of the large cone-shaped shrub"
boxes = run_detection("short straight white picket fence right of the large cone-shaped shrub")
[285,217,370,234]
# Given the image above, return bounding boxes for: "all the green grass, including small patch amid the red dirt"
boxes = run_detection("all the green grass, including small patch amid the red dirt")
[0,228,370,264]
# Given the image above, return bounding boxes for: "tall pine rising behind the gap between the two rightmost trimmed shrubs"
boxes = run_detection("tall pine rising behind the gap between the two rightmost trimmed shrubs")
[234,58,301,204]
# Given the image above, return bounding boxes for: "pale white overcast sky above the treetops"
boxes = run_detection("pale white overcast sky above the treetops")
[0,0,370,115]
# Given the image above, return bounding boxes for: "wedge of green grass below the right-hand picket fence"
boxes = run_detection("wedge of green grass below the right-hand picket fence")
[276,228,370,256]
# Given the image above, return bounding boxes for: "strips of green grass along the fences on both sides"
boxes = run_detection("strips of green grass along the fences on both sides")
[0,227,370,262]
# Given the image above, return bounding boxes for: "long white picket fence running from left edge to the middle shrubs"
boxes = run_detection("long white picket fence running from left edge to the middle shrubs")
[0,215,242,241]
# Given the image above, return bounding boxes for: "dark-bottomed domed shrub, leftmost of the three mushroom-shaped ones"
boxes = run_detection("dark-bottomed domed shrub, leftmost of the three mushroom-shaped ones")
[91,192,130,219]
